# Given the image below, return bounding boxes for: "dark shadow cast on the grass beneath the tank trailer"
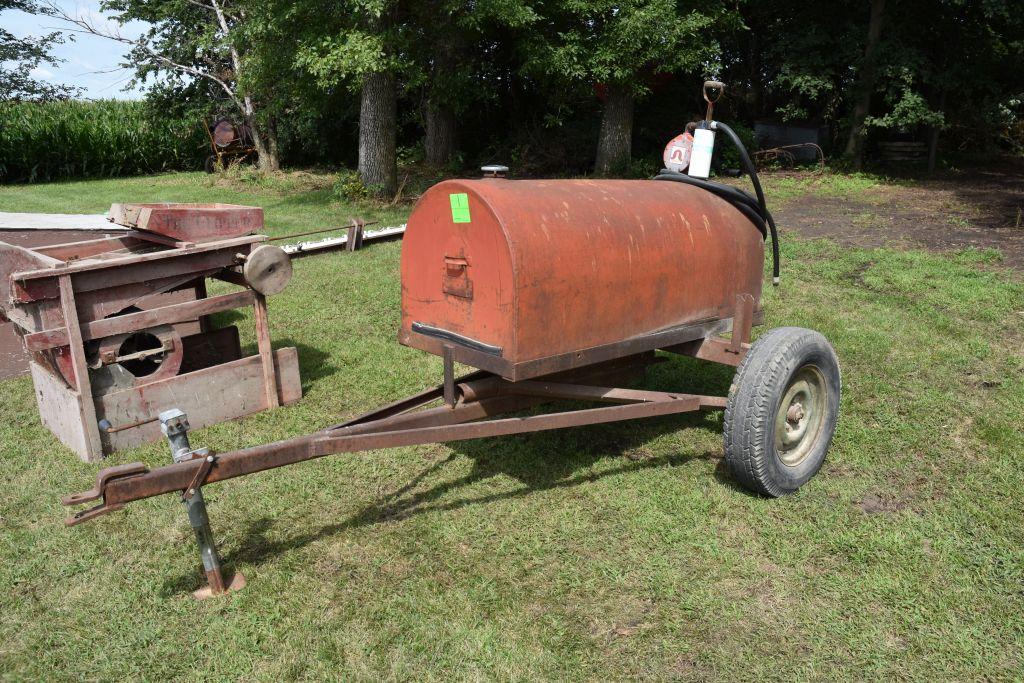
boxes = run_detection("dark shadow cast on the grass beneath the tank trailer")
[162,351,755,597]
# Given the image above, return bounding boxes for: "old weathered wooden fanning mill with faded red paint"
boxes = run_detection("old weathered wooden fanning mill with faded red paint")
[0,204,301,461]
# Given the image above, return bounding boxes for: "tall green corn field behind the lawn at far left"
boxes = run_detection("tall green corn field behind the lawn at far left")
[0,99,207,182]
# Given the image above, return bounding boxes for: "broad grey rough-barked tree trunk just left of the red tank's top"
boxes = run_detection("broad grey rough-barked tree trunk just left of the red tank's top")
[358,72,398,197]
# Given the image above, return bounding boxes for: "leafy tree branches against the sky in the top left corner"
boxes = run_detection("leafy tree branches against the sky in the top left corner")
[0,0,81,101]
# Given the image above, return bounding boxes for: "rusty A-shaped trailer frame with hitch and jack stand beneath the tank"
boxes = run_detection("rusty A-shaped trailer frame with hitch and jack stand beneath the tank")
[61,295,762,598]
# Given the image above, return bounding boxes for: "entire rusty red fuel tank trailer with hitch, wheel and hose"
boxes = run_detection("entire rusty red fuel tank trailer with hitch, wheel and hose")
[63,83,840,594]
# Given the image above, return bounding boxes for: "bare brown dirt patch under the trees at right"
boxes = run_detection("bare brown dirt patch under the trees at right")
[774,170,1024,272]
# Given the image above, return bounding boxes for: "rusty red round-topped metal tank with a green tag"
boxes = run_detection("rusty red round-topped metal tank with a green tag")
[399,178,764,381]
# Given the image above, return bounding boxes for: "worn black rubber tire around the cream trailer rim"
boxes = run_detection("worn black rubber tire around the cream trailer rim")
[724,328,842,498]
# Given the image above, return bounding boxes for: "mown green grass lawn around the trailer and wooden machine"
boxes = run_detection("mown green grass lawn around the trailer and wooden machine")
[0,174,1024,681]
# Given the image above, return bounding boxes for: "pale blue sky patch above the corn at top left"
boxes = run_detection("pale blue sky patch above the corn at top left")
[0,0,145,99]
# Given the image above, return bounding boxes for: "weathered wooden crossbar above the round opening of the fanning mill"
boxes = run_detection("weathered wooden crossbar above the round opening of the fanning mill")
[25,290,255,351]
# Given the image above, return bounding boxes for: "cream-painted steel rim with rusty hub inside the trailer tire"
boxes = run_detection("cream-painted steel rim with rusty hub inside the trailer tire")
[775,365,826,467]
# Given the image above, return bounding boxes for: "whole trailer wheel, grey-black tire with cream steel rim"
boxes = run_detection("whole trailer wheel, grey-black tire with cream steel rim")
[725,328,841,497]
